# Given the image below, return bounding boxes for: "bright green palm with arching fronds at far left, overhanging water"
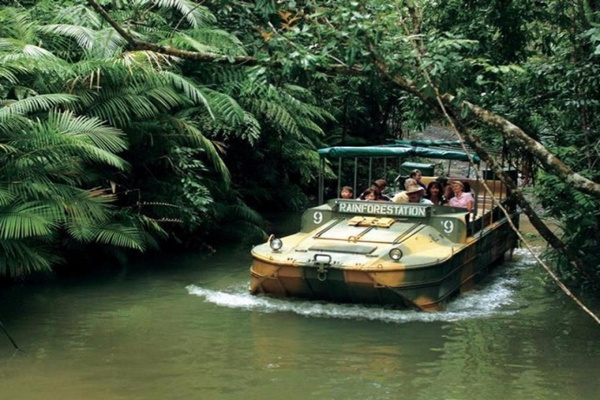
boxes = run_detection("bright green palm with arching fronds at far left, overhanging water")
[0,103,160,277]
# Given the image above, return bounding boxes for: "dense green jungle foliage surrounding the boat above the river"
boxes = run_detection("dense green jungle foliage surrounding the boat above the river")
[0,0,600,294]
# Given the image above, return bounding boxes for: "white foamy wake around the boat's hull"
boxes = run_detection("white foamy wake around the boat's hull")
[186,250,532,323]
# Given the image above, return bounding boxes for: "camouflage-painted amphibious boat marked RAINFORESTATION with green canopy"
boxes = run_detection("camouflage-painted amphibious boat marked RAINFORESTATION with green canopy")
[250,141,519,310]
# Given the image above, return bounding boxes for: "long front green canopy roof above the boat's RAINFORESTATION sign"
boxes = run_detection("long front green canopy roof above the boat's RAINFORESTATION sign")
[318,143,481,164]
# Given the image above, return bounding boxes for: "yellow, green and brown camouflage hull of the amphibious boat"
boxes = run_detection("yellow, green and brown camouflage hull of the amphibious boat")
[250,203,518,311]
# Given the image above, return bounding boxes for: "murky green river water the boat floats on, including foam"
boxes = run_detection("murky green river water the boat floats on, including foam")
[0,214,600,400]
